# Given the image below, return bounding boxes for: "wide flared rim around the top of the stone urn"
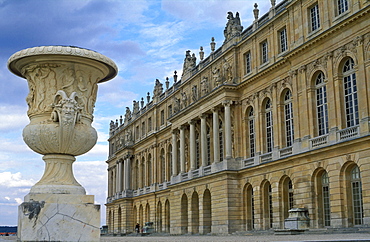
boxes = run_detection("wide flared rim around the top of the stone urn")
[7,45,118,83]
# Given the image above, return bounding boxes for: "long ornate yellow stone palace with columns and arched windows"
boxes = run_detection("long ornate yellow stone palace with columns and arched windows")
[106,0,370,234]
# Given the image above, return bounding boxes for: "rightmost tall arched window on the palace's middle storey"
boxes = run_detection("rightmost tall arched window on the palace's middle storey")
[343,58,359,127]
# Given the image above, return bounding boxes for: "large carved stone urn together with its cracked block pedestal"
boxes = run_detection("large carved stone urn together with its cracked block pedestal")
[8,46,117,241]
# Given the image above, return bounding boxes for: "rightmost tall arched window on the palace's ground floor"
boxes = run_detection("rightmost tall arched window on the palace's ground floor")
[351,166,364,225]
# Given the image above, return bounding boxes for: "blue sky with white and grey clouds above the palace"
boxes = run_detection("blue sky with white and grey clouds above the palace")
[0,0,280,226]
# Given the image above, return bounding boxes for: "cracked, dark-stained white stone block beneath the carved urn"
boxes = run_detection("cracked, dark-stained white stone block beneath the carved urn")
[18,194,100,241]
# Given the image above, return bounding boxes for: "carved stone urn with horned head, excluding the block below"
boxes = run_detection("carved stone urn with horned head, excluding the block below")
[8,46,117,193]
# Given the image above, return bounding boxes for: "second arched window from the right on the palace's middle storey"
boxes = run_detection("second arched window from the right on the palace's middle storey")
[315,72,329,136]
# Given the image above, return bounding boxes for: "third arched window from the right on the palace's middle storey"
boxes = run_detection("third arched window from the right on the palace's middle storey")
[284,90,294,147]
